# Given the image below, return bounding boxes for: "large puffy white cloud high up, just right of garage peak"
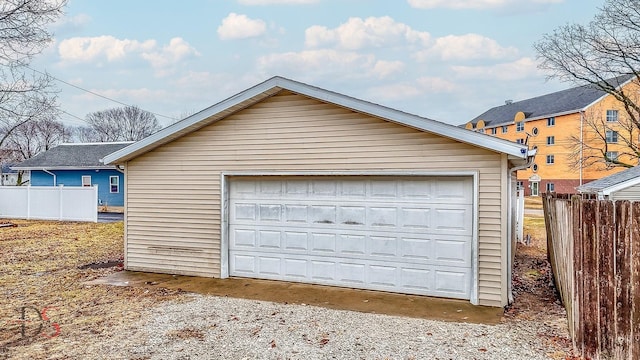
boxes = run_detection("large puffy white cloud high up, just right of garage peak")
[305,16,430,50]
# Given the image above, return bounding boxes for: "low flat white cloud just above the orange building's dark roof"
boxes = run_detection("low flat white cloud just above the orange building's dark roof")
[451,57,542,81]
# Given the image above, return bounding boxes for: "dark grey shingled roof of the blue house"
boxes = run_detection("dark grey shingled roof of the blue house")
[11,141,133,170]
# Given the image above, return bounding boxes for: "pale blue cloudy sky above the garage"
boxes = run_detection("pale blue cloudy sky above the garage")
[33,0,603,125]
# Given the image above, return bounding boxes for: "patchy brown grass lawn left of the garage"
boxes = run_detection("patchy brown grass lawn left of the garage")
[0,220,185,359]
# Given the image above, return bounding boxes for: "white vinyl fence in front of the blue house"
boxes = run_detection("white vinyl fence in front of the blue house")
[0,186,98,222]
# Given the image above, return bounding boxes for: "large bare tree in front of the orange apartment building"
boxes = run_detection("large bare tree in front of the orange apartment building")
[534,0,640,167]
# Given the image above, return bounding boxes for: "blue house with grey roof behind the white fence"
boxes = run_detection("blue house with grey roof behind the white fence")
[11,142,132,206]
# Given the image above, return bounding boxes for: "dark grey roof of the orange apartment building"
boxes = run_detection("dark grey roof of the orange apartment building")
[468,75,632,127]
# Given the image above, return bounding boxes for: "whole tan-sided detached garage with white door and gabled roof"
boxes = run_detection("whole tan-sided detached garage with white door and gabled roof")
[104,77,534,306]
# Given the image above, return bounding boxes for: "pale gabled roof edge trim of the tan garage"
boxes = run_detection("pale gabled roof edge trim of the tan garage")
[104,76,532,164]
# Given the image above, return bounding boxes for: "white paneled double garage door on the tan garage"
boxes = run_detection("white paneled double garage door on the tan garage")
[228,176,473,299]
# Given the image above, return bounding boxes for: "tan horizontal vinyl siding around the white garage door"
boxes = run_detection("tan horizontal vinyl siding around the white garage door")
[126,92,506,306]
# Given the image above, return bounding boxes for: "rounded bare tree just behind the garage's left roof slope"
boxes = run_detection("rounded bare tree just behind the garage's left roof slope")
[76,106,160,142]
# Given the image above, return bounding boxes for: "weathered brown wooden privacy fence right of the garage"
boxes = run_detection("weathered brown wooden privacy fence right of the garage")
[543,194,640,359]
